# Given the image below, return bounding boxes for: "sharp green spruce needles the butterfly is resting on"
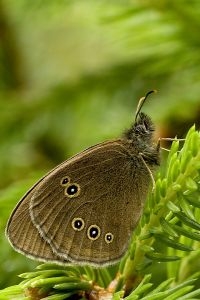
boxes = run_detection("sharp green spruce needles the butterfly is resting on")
[0,126,200,300]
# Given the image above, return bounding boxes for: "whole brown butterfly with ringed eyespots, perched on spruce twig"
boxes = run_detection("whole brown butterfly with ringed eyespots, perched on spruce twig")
[6,91,160,267]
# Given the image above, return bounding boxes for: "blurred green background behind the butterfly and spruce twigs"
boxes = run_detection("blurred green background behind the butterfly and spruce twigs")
[0,0,200,288]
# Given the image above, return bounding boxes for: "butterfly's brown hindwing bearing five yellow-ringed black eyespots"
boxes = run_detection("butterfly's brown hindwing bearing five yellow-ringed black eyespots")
[26,140,150,265]
